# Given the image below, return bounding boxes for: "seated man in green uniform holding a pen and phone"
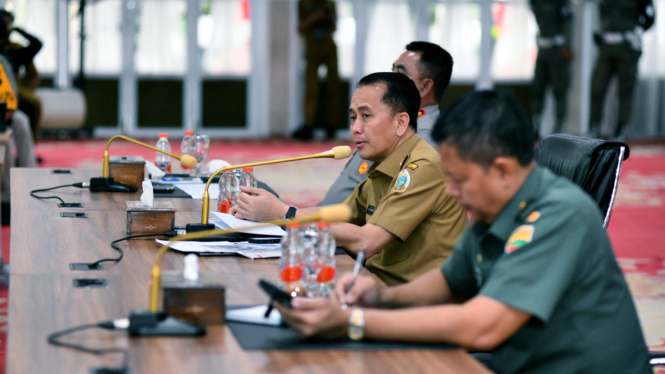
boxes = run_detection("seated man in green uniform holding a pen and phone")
[277,91,651,374]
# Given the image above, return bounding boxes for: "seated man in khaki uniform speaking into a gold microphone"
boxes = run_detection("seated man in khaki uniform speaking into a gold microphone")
[231,73,467,285]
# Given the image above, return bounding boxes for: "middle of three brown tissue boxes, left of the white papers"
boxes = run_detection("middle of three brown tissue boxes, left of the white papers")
[125,201,176,235]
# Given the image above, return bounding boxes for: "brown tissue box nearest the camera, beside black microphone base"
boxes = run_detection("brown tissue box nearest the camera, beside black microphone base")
[161,271,226,325]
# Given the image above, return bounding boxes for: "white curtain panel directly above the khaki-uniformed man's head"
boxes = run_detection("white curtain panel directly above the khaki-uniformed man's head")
[364,1,415,74]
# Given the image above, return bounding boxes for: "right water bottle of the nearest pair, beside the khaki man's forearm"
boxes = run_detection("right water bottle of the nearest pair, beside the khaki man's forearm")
[315,221,337,297]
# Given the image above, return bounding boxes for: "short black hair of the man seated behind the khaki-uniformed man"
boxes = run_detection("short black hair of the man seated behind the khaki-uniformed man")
[406,42,453,103]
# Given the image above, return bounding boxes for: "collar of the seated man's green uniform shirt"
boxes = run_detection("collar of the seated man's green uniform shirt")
[489,166,543,241]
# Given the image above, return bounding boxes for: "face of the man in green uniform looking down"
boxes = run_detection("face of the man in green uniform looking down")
[439,143,507,223]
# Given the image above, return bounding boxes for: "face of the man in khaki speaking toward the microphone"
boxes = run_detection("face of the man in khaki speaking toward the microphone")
[349,84,399,162]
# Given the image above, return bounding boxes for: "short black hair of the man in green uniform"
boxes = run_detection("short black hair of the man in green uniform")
[432,91,535,167]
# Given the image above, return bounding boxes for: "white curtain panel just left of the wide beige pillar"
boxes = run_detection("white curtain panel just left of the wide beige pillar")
[199,0,251,75]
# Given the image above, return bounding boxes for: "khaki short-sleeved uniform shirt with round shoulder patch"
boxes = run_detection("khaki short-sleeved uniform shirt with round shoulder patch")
[345,135,467,285]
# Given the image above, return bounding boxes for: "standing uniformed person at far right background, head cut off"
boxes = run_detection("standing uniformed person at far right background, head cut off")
[589,0,656,141]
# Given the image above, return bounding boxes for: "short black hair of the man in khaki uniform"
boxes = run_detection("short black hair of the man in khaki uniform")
[357,73,420,131]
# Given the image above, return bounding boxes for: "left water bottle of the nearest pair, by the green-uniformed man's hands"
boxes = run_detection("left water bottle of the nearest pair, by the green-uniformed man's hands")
[279,222,307,297]
